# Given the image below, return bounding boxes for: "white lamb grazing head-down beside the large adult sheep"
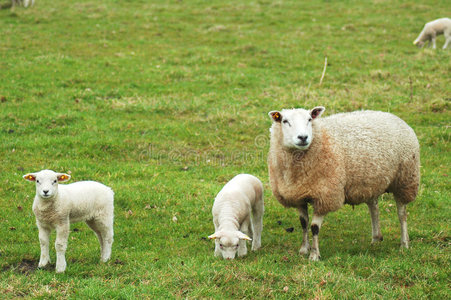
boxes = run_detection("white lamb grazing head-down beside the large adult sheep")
[208,174,264,259]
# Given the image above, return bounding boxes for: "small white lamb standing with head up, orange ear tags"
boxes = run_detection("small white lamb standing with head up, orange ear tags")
[23,170,114,273]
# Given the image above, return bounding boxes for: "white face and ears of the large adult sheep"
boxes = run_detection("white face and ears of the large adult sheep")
[269,106,325,150]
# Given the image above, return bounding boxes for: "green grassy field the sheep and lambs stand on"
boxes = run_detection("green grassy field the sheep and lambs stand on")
[0,0,451,299]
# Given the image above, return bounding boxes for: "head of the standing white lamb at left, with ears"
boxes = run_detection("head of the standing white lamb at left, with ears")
[23,170,70,199]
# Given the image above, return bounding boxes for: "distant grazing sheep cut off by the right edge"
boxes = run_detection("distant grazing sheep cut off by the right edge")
[413,18,451,49]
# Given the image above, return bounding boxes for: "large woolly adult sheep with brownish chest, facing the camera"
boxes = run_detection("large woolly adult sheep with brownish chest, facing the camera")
[268,106,420,260]
